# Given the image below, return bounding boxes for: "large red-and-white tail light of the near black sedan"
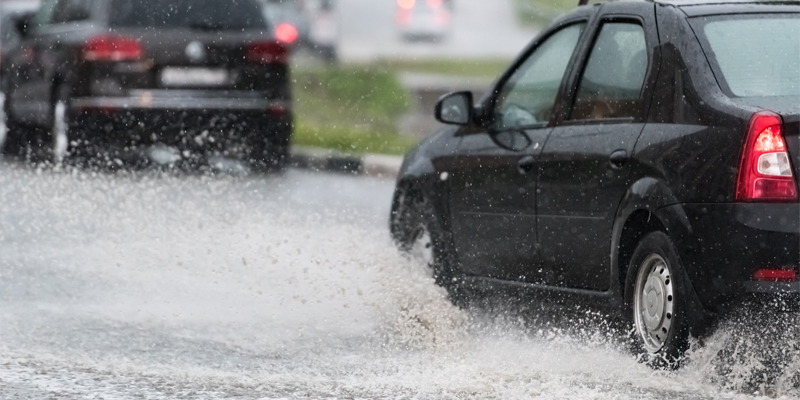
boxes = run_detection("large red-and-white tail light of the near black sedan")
[736,111,797,201]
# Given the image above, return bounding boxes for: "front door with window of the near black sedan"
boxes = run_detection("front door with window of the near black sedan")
[450,20,586,281]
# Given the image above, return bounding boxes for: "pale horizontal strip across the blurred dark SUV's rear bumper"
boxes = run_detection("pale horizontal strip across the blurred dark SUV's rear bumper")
[70,90,290,111]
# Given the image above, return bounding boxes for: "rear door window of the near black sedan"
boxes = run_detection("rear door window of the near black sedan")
[570,22,648,120]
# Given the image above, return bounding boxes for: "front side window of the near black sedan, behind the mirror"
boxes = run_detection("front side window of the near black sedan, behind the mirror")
[492,23,586,130]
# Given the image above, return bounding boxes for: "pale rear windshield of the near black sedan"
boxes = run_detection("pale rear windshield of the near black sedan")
[697,14,800,97]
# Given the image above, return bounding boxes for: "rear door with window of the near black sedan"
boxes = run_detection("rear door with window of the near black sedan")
[537,3,658,291]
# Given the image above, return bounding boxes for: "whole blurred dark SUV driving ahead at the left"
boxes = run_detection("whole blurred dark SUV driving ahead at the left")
[3,0,292,168]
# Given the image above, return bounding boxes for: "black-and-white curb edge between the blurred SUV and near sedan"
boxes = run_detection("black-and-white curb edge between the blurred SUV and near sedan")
[289,146,403,178]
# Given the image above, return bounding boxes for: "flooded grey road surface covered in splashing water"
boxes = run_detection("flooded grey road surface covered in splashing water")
[0,164,800,399]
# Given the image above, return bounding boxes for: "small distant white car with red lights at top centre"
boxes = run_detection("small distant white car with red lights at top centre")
[395,0,452,41]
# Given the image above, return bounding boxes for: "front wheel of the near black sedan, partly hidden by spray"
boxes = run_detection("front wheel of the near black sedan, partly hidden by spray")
[392,190,468,308]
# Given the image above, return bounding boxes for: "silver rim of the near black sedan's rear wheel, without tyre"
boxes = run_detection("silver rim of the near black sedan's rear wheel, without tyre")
[633,254,675,353]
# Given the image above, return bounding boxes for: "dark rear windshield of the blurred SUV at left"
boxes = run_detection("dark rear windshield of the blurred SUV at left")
[110,0,267,31]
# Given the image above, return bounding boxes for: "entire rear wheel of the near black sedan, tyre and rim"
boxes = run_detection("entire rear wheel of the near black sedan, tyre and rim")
[625,232,697,369]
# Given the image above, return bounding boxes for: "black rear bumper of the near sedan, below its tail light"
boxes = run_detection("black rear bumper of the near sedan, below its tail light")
[670,204,800,311]
